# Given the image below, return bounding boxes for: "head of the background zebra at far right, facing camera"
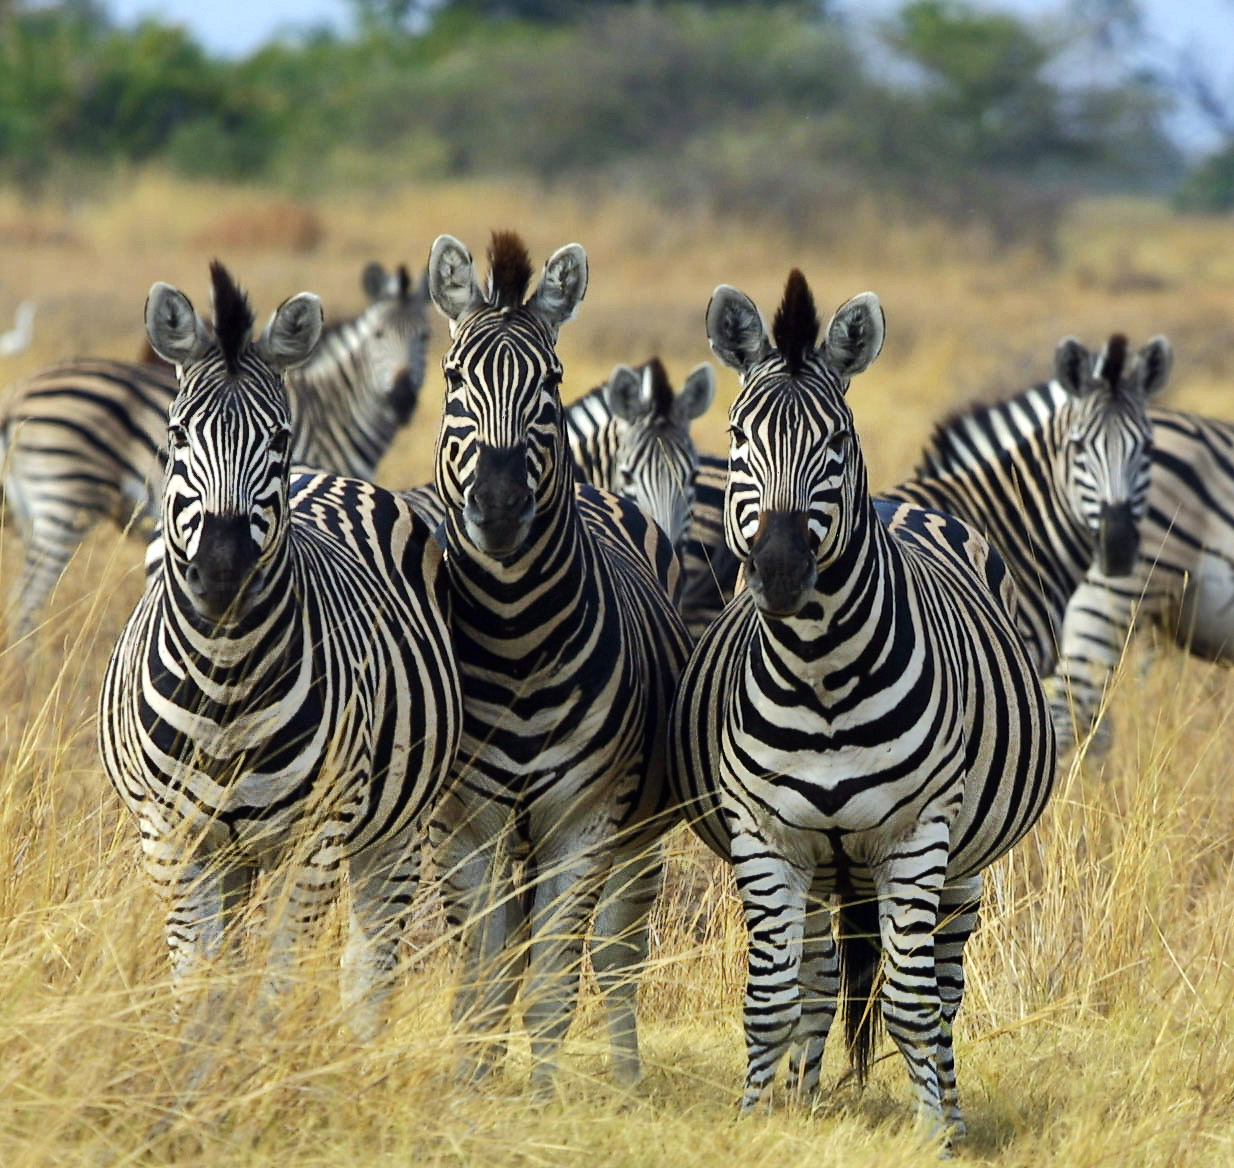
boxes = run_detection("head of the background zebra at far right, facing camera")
[1054,333,1174,576]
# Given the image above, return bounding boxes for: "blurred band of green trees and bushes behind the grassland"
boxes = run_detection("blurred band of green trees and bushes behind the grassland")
[0,0,1234,250]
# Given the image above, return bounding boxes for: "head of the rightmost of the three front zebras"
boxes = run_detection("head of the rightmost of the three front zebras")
[707,269,884,617]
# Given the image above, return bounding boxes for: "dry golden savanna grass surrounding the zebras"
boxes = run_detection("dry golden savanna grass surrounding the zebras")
[0,175,1234,1168]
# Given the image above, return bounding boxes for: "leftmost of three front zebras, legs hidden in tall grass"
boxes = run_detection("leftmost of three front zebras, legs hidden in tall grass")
[99,263,462,1036]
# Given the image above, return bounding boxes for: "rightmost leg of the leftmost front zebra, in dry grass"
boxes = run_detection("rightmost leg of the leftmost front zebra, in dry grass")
[341,829,420,1041]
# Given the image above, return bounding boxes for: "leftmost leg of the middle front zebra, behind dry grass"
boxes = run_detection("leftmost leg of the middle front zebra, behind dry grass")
[434,831,527,1082]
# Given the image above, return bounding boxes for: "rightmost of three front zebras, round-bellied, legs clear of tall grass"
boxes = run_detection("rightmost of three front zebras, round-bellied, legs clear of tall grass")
[669,270,1055,1133]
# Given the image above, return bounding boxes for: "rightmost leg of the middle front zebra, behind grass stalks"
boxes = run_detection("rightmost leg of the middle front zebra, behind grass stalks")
[591,842,663,1087]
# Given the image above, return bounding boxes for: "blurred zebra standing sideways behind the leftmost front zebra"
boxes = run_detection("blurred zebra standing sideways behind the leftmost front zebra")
[0,263,428,643]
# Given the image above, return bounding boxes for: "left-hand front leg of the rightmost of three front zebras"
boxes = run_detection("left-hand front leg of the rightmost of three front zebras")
[732,834,813,1112]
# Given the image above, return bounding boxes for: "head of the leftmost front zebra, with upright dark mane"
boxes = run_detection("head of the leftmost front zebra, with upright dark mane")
[146,260,322,624]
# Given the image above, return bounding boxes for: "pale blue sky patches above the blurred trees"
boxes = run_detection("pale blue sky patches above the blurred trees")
[105,0,1234,146]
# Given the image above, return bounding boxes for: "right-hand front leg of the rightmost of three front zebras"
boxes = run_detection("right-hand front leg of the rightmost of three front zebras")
[875,818,950,1129]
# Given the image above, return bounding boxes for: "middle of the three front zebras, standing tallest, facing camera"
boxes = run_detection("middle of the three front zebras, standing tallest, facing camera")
[428,232,687,1092]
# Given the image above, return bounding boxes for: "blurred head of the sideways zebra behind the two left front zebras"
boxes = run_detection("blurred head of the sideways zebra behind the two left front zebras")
[355,261,429,426]
